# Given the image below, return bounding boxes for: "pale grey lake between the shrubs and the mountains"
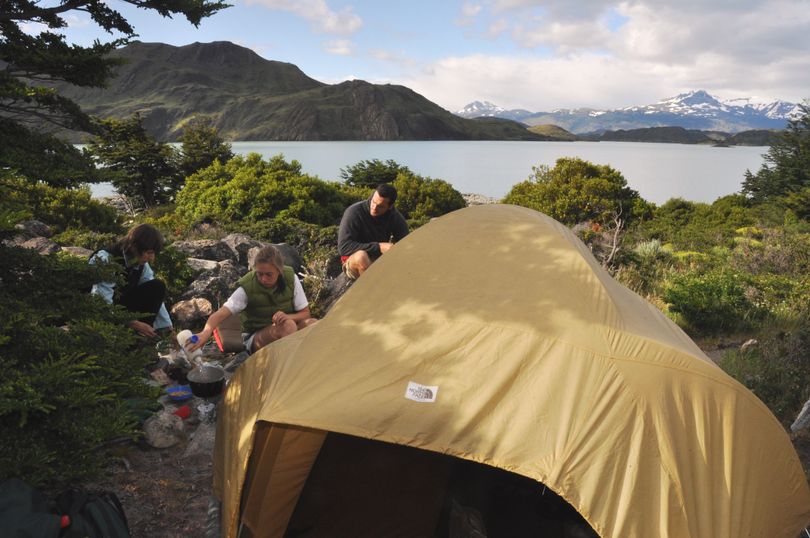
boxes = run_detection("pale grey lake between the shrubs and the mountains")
[92,141,768,204]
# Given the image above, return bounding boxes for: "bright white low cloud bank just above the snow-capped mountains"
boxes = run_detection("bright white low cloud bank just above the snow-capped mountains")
[402,43,810,112]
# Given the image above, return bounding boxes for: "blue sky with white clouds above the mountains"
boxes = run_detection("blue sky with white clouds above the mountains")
[41,0,810,112]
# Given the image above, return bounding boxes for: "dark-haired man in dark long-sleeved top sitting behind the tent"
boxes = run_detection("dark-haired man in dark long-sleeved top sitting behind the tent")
[338,183,408,278]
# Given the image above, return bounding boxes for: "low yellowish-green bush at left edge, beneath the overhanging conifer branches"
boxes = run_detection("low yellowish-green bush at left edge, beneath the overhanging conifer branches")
[0,177,123,234]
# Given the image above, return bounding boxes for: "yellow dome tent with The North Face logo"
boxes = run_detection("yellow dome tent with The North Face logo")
[214,205,810,538]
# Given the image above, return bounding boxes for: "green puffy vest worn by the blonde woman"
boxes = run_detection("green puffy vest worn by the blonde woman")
[237,265,295,333]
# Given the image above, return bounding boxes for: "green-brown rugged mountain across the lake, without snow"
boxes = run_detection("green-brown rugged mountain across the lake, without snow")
[57,42,548,140]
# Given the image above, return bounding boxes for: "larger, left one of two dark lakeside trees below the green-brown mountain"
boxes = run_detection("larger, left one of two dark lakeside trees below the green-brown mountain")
[87,114,183,207]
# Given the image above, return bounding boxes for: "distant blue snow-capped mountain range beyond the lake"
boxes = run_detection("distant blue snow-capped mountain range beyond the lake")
[456,90,799,134]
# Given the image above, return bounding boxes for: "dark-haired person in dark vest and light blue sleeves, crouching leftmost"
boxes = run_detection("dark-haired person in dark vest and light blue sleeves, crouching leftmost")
[90,224,172,338]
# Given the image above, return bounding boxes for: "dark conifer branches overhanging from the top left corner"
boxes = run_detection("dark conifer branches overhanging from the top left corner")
[0,0,227,186]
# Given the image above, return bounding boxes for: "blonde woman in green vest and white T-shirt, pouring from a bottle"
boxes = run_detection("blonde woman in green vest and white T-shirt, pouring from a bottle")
[188,246,317,353]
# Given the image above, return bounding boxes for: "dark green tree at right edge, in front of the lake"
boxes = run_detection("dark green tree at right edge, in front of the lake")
[742,103,810,207]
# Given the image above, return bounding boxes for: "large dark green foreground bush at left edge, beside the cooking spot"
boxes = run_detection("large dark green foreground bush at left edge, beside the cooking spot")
[0,246,156,487]
